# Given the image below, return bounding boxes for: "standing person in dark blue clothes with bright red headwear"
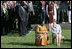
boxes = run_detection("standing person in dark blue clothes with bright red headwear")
[40,1,46,22]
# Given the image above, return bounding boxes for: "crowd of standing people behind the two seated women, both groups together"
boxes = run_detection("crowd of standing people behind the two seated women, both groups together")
[1,1,71,34]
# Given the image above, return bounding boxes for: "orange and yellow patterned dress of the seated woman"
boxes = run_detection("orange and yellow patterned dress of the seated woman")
[35,25,47,45]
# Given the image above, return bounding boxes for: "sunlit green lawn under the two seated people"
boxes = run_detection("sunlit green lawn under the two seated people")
[1,28,71,48]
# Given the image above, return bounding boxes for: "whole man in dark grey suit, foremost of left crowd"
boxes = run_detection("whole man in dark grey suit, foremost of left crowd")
[16,1,28,36]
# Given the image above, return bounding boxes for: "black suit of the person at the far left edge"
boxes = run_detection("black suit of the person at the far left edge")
[1,5,9,34]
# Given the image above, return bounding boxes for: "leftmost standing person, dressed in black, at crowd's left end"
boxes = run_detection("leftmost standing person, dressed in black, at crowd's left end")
[3,1,9,34]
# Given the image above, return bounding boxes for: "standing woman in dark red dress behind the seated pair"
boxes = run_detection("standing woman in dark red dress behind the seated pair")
[46,1,54,31]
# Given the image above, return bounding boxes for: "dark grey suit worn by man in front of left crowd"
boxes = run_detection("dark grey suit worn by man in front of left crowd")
[16,3,28,36]
